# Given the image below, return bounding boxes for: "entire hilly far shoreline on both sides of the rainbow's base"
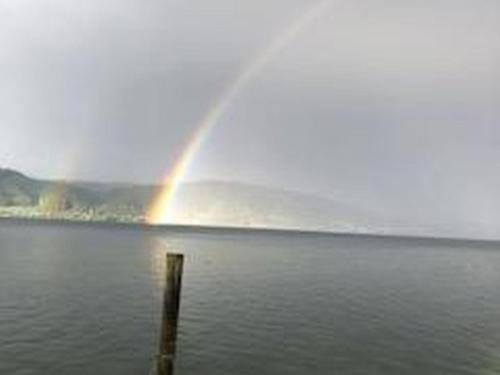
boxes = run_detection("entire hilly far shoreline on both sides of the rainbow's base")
[0,169,373,232]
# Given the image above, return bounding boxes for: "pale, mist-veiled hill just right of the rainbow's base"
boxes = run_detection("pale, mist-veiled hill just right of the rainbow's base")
[170,181,373,232]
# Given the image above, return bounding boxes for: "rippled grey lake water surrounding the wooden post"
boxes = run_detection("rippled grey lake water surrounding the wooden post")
[0,221,500,375]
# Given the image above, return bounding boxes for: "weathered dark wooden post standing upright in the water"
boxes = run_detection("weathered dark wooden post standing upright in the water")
[158,254,184,375]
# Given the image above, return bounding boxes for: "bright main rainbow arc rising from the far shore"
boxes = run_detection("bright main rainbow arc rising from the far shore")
[147,0,332,224]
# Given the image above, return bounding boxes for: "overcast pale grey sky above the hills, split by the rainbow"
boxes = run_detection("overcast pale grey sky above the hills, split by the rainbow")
[0,0,500,229]
